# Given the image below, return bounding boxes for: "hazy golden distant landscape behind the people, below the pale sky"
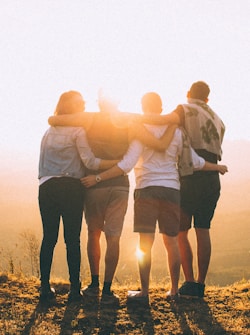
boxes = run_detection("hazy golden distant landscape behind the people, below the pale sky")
[0,141,250,286]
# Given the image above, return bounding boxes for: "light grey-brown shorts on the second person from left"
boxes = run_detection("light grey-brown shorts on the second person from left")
[85,186,129,236]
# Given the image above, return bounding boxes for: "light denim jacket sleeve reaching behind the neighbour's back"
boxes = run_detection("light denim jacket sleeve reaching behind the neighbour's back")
[76,128,101,170]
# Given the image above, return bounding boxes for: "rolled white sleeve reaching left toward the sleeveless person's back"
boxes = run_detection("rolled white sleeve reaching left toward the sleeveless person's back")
[117,140,143,173]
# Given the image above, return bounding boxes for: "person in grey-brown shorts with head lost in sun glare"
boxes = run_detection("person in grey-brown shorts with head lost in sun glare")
[83,101,129,304]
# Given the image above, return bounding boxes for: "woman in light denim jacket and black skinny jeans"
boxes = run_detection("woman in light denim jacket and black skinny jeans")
[38,91,86,302]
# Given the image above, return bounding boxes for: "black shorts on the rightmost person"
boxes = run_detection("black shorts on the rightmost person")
[180,172,220,231]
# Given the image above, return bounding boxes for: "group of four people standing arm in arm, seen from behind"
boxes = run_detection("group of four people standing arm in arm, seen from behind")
[39,82,227,304]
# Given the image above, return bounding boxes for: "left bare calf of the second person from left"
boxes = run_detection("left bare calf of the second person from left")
[87,230,101,275]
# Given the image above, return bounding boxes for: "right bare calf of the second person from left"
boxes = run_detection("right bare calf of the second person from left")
[104,236,120,283]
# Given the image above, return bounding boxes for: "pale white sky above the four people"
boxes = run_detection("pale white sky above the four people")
[0,0,250,161]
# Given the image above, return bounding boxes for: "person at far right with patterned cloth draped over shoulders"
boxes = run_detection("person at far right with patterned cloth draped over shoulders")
[158,81,225,298]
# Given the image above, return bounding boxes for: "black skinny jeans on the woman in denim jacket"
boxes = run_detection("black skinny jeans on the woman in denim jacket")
[39,177,84,288]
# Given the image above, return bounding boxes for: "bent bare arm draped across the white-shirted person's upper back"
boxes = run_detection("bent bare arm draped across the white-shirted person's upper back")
[129,123,177,151]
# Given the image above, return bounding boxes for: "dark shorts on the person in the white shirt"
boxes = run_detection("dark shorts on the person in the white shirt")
[134,186,180,236]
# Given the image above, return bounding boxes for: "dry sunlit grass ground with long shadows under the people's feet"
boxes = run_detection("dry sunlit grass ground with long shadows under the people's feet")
[0,274,250,335]
